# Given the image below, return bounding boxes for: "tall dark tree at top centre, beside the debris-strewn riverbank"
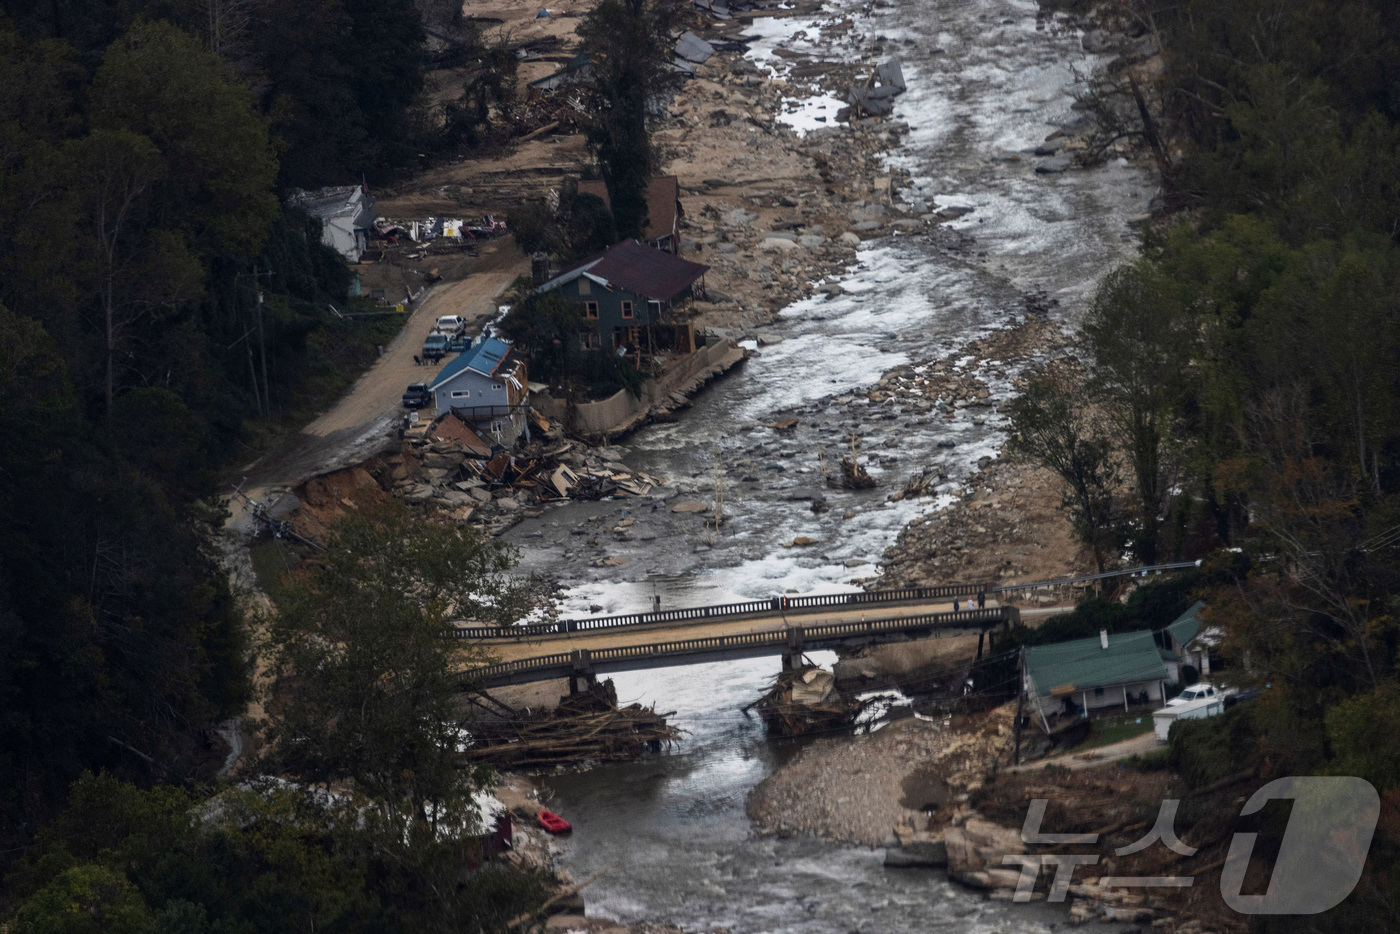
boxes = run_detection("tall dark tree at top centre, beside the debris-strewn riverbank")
[578,0,678,239]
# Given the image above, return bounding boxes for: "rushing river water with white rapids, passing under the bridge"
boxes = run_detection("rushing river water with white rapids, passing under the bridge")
[511,0,1154,933]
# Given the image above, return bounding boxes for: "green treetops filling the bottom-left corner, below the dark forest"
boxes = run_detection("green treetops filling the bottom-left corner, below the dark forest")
[0,774,557,934]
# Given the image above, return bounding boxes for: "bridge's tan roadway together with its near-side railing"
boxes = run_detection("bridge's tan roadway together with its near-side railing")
[462,606,1021,692]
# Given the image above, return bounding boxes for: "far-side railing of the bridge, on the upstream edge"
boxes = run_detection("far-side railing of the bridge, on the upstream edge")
[451,584,987,639]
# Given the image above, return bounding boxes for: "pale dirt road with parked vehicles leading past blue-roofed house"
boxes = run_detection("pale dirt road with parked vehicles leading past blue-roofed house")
[235,239,529,518]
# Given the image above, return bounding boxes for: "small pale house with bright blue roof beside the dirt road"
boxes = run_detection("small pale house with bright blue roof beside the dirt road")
[428,337,529,448]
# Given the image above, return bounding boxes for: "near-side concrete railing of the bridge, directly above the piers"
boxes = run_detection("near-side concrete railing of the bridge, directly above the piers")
[462,606,1021,688]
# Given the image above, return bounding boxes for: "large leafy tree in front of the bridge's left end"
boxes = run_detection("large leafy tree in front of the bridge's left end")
[267,506,525,835]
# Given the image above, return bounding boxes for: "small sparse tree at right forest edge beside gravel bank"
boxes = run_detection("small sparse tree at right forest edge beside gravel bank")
[1007,374,1124,571]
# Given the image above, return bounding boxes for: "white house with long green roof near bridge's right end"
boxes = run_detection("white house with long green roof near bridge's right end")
[1022,630,1169,732]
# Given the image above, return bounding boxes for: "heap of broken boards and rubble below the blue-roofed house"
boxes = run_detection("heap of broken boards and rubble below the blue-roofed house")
[389,413,661,524]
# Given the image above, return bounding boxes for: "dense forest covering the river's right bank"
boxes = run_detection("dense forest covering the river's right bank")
[1009,0,1400,931]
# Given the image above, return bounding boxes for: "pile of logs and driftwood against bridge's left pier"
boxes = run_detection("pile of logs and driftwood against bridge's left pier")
[470,679,680,770]
